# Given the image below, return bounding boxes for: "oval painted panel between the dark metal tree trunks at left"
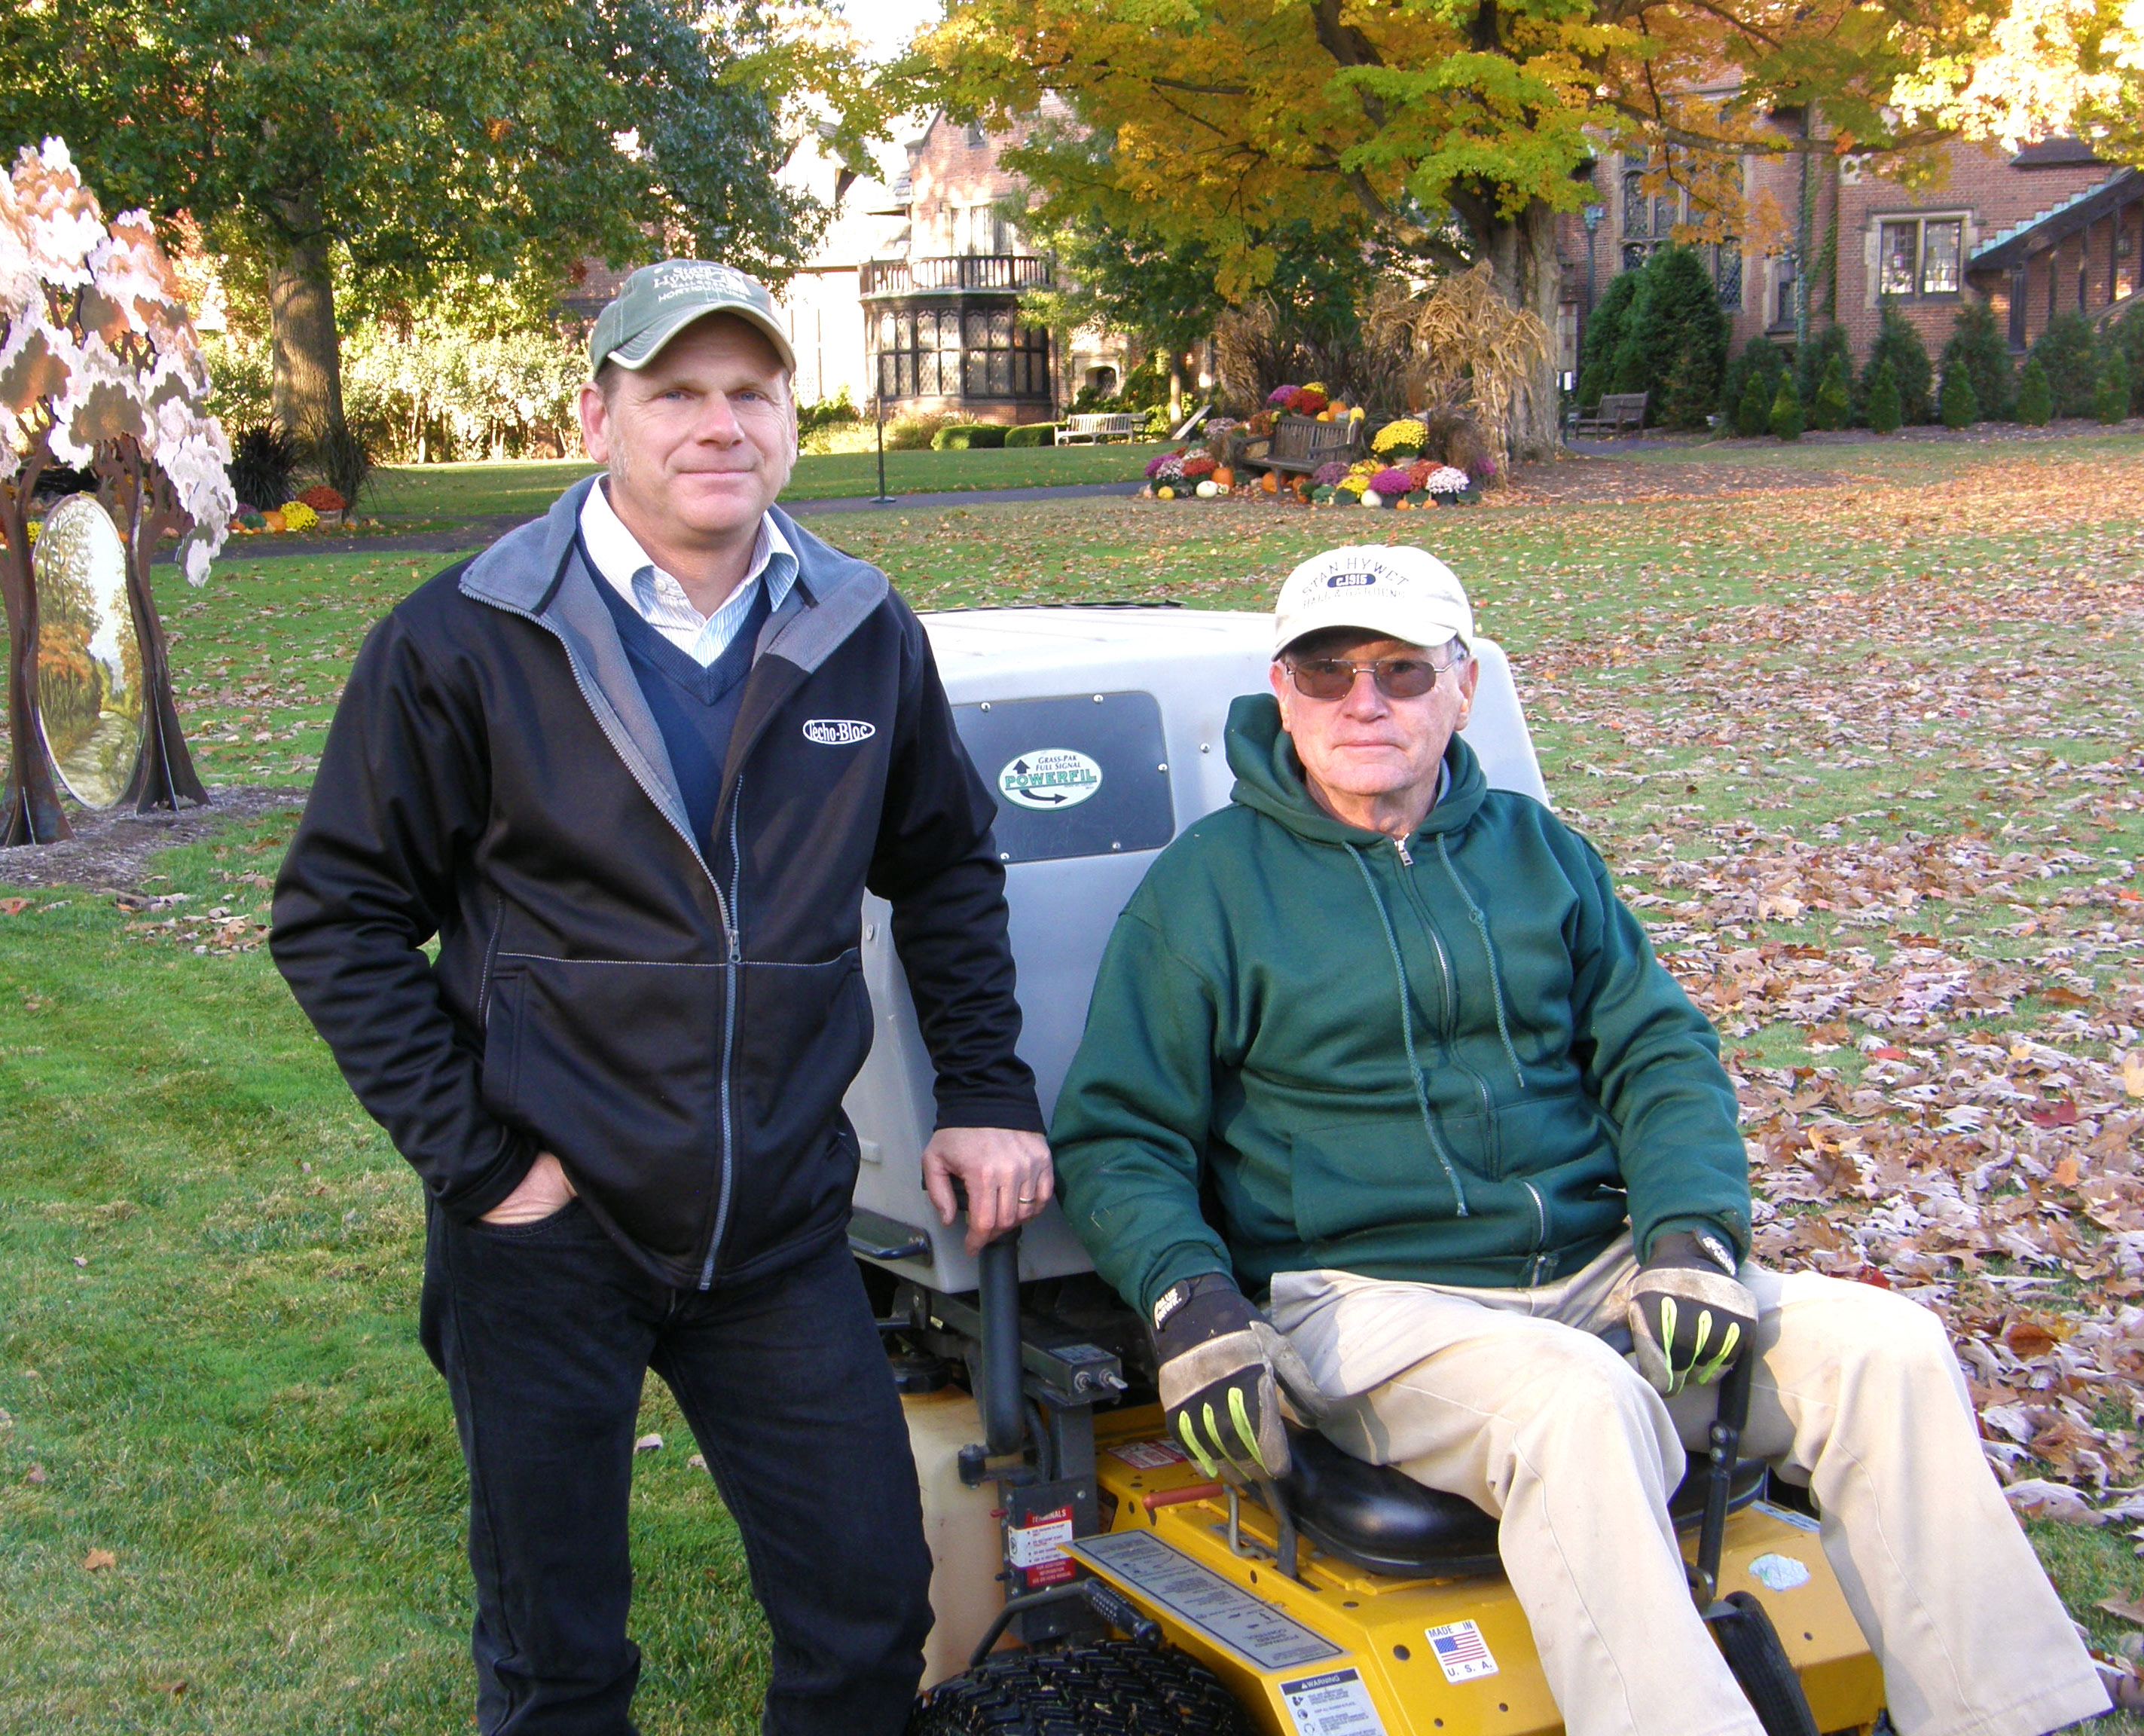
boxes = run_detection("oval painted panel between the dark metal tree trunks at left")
[32,495,142,808]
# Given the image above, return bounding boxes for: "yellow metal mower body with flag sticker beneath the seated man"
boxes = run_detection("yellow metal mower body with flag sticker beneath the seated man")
[1072,1406,1883,1736]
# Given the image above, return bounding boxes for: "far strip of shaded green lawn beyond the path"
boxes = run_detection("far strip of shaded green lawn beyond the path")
[365,444,1160,523]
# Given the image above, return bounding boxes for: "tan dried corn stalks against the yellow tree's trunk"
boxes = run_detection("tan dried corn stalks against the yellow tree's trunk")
[1361,264,1548,457]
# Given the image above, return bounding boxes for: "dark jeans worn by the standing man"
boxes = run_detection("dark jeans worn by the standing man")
[423,1203,930,1736]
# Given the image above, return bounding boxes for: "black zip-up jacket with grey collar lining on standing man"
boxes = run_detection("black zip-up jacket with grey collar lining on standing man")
[270,482,1042,1288]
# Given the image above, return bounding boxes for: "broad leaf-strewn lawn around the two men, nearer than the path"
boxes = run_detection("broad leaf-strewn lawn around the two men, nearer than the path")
[0,435,2144,1736]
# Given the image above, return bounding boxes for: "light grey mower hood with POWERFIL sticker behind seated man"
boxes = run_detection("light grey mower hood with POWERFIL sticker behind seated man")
[844,607,1548,1292]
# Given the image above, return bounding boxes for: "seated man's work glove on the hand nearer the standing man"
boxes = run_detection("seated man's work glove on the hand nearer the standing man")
[1153,1271,1325,1479]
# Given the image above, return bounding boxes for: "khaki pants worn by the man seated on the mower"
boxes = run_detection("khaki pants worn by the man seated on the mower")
[1272,1236,2108,1736]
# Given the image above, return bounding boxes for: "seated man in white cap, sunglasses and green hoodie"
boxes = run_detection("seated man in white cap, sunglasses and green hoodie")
[1052,549,2108,1736]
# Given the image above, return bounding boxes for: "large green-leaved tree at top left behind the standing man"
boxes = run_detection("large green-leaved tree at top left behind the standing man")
[0,0,872,452]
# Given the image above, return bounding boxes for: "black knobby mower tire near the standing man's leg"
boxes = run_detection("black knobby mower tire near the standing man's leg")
[907,1640,1252,1736]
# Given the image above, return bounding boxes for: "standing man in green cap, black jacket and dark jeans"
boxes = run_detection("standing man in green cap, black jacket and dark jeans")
[272,259,1051,1736]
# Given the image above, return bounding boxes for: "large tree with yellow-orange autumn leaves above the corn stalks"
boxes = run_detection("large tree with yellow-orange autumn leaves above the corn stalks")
[918,0,2000,457]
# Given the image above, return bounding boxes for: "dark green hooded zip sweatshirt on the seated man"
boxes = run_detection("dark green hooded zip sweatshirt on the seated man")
[1051,695,1749,1314]
